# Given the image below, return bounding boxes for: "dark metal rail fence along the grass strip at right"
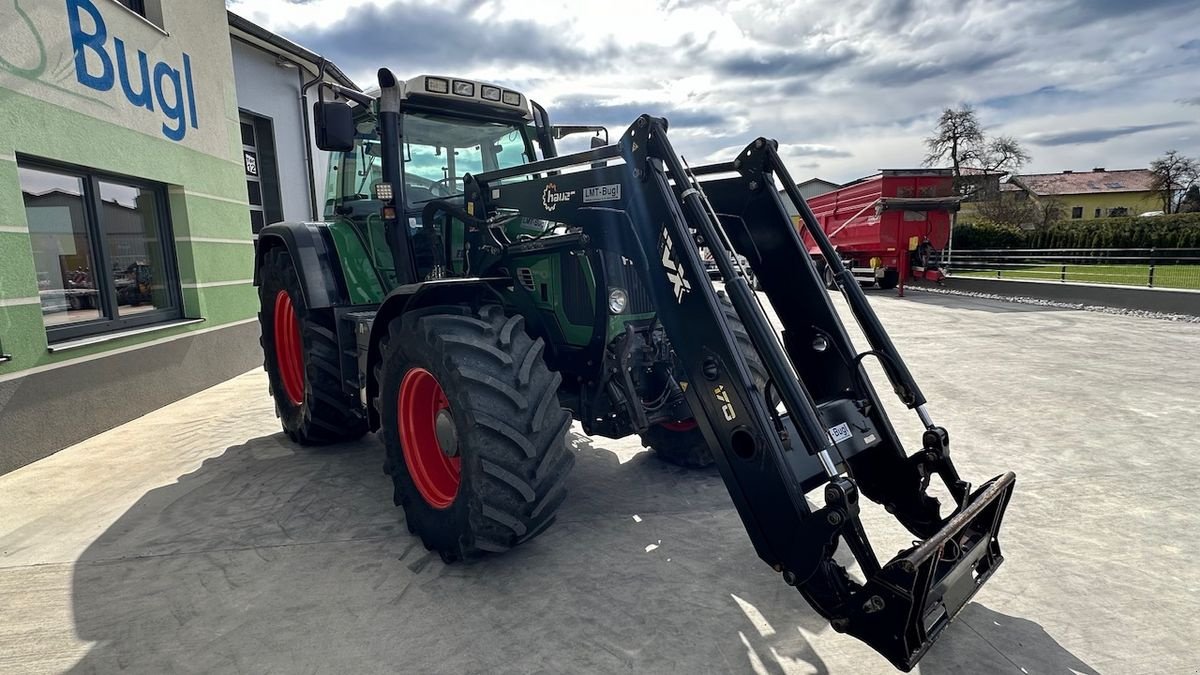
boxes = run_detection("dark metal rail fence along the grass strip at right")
[942,249,1200,289]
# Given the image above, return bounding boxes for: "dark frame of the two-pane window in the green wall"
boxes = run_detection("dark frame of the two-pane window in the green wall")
[17,153,184,346]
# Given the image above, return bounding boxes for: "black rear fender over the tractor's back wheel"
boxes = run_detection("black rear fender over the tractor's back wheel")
[254,222,346,309]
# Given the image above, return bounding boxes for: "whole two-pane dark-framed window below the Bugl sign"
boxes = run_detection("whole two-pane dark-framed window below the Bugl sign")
[17,161,179,341]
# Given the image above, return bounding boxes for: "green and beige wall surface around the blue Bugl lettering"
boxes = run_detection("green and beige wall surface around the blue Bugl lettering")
[0,0,257,377]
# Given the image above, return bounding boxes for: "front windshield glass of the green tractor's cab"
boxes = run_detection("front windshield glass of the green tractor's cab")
[402,113,530,205]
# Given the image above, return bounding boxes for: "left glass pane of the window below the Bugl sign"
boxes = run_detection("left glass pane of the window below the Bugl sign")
[17,167,101,325]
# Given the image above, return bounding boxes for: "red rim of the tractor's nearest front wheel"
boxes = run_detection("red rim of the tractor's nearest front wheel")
[396,368,462,508]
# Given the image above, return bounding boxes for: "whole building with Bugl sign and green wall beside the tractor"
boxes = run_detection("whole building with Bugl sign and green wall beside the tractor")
[0,0,350,473]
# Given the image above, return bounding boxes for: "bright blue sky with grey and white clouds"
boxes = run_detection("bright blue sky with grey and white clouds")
[227,0,1200,183]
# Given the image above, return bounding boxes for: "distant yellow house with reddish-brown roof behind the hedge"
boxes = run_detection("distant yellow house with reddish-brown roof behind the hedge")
[1008,167,1163,221]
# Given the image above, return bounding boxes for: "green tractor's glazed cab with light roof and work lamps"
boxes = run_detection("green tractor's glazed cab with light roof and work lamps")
[314,76,544,283]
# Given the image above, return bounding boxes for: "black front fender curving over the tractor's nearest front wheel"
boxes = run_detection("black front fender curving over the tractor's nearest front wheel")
[359,276,512,431]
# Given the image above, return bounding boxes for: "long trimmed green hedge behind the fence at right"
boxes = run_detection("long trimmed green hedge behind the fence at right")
[954,214,1200,249]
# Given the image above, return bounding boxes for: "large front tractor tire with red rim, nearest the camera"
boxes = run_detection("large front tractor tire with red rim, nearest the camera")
[376,305,575,562]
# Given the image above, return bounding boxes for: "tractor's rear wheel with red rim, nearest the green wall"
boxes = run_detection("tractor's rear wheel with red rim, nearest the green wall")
[258,247,367,446]
